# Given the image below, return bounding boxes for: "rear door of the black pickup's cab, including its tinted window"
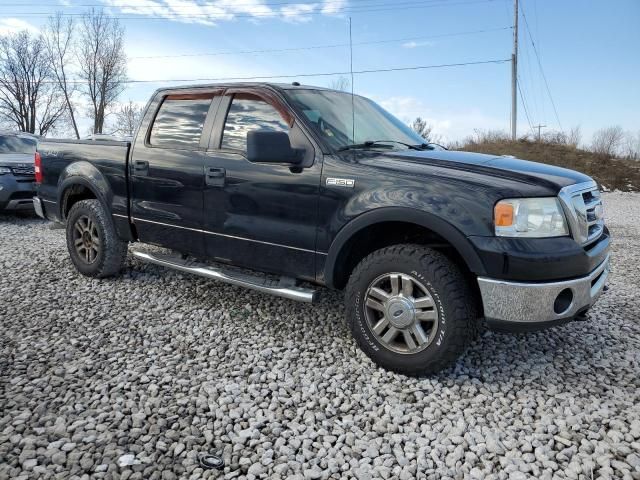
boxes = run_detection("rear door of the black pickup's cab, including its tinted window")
[129,91,219,255]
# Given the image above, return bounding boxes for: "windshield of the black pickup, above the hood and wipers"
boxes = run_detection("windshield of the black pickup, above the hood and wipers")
[287,89,426,150]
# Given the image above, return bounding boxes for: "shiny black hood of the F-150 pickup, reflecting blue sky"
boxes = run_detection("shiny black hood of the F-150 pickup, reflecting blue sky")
[359,150,591,191]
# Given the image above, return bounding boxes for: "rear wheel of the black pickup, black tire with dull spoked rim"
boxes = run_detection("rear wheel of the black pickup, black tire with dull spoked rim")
[66,200,128,278]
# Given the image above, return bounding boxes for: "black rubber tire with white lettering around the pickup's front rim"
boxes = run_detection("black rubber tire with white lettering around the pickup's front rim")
[345,244,478,376]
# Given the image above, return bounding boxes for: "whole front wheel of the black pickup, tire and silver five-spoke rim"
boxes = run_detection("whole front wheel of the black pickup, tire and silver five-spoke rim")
[345,244,477,376]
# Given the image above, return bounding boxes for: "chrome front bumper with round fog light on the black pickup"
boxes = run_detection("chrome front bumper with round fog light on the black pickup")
[478,255,609,325]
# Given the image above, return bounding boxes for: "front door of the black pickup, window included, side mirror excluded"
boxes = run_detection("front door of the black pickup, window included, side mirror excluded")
[203,89,322,279]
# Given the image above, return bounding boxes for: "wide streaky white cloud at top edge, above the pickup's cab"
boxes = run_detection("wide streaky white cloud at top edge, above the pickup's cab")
[104,0,347,25]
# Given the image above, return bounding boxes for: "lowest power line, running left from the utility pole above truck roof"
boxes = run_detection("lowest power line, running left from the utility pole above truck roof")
[0,59,511,84]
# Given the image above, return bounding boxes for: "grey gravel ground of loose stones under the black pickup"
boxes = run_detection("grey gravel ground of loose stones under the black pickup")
[0,193,640,480]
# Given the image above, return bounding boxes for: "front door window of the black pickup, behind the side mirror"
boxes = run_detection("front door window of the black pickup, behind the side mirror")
[222,93,289,152]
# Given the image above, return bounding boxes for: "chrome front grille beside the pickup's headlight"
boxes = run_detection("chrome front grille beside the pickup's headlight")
[559,182,604,246]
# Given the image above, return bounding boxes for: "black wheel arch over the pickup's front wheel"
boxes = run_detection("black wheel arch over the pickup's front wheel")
[324,207,485,289]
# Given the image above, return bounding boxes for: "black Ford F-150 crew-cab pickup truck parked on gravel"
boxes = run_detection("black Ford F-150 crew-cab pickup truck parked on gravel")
[34,83,610,375]
